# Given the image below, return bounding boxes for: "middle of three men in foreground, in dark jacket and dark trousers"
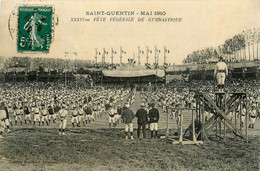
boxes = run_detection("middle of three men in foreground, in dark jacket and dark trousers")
[135,103,148,138]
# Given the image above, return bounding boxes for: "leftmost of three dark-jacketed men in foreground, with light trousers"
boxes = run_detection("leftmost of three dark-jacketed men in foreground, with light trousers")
[122,104,135,139]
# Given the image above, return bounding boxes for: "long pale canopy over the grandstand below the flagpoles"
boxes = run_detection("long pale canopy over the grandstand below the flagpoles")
[102,69,165,77]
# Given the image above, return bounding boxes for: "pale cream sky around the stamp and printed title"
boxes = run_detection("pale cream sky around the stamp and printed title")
[0,0,260,64]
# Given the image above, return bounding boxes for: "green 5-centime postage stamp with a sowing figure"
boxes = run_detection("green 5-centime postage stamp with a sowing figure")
[17,6,53,53]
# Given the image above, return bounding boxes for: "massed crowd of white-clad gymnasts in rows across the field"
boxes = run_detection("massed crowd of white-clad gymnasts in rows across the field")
[0,79,260,138]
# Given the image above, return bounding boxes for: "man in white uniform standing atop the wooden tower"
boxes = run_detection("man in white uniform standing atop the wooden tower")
[214,57,228,92]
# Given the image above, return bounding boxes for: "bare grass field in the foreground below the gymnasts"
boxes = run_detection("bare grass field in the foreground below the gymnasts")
[0,128,260,170]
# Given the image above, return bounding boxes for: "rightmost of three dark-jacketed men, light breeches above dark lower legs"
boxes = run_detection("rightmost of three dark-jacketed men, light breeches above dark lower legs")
[149,103,159,138]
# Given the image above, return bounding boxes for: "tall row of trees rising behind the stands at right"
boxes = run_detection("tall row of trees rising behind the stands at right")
[183,28,260,63]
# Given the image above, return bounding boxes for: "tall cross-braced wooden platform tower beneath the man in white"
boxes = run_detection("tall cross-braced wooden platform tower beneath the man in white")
[195,92,248,142]
